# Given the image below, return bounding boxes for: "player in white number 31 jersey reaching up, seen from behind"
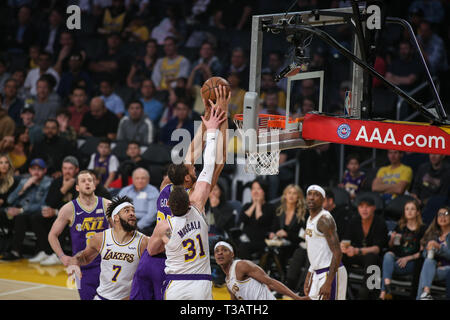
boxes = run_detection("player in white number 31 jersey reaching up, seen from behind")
[148,106,226,300]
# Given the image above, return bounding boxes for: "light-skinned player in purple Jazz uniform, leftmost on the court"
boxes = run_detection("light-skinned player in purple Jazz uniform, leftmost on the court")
[48,170,110,300]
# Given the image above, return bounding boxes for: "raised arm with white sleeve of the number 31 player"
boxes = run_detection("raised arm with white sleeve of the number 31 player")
[189,102,227,211]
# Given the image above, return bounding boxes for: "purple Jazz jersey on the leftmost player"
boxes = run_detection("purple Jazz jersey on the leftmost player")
[70,196,109,268]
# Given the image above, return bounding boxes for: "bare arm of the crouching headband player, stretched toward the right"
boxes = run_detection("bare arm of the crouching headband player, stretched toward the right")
[236,260,309,300]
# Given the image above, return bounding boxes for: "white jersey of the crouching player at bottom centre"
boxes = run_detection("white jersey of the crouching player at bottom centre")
[225,259,276,300]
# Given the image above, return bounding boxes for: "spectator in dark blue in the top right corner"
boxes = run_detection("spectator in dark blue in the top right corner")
[417,20,448,76]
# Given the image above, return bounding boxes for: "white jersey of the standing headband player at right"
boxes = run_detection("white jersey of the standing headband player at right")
[305,209,333,270]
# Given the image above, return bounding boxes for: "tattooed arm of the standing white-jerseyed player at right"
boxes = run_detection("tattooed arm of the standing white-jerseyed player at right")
[317,216,342,300]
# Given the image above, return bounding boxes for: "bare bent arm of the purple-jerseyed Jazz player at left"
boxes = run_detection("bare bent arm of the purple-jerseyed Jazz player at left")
[48,202,74,267]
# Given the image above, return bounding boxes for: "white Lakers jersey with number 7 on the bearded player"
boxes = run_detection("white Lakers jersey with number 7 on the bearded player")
[97,228,144,300]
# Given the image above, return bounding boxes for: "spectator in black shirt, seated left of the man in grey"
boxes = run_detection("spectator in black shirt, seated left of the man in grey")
[79,97,119,140]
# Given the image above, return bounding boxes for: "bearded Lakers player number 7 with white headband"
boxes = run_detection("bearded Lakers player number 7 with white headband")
[67,196,148,300]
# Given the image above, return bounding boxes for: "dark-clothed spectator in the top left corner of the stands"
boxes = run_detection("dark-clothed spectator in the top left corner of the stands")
[6,5,37,53]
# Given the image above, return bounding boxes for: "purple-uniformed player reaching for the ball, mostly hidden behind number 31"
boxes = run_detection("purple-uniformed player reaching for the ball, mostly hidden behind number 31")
[130,87,230,300]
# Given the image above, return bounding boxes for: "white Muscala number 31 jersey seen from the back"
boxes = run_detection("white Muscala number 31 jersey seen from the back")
[164,206,211,274]
